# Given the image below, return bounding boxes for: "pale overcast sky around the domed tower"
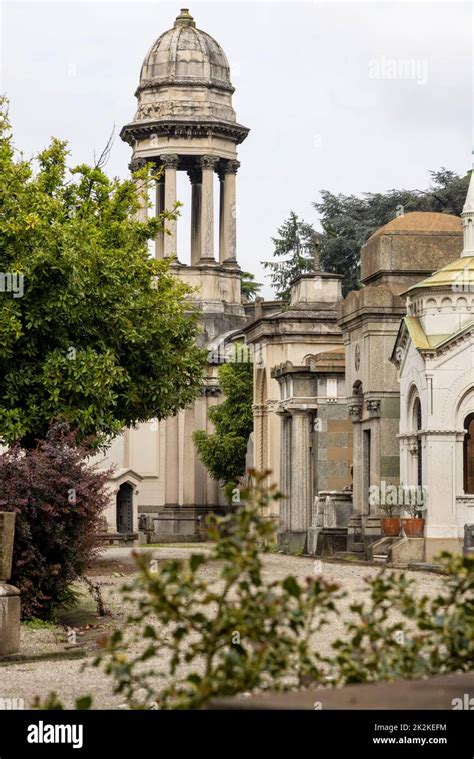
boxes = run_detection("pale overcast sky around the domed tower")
[0,0,473,297]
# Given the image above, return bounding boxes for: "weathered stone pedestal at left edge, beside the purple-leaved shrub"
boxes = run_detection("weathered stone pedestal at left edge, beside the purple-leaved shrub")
[0,511,20,656]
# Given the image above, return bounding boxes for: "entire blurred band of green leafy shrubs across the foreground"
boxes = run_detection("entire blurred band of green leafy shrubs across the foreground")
[92,473,474,709]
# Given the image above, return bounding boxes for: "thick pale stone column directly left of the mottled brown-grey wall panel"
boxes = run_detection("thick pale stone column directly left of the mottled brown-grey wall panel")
[290,409,311,550]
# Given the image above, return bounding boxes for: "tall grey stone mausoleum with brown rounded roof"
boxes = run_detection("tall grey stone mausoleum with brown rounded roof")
[339,212,462,555]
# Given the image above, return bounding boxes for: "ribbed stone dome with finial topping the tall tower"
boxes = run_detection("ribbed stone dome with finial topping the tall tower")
[140,8,233,91]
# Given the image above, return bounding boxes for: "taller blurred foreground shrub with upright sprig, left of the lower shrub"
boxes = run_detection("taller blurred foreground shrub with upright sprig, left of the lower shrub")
[98,475,337,709]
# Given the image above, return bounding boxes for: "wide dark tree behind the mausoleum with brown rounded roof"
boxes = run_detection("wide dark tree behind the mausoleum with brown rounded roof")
[313,168,469,294]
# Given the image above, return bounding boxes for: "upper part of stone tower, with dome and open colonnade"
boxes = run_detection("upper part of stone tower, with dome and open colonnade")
[120,9,249,338]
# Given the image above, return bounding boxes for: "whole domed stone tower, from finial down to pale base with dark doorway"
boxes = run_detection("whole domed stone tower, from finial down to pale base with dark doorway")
[108,9,249,540]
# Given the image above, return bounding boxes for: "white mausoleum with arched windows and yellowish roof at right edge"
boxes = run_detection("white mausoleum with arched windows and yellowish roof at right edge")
[392,172,474,561]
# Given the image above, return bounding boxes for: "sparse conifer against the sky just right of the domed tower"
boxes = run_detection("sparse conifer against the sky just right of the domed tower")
[262,211,315,300]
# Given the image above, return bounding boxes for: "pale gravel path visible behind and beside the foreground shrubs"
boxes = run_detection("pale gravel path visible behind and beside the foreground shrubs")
[0,545,443,709]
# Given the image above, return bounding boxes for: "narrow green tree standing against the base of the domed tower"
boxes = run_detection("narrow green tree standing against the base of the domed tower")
[193,346,253,485]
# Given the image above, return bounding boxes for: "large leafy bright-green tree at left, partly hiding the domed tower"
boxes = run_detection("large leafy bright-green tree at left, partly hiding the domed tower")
[0,102,205,447]
